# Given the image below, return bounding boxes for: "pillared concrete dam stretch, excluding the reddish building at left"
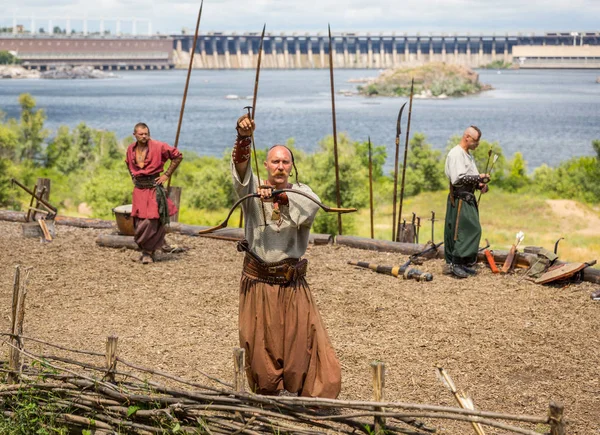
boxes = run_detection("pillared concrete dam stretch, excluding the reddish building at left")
[173,32,600,69]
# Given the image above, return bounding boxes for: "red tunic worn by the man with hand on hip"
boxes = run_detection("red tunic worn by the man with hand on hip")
[125,139,181,219]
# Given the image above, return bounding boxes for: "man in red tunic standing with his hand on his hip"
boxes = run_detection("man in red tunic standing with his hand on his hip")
[125,122,183,264]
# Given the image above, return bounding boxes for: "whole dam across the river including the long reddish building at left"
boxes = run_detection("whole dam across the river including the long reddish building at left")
[0,32,600,70]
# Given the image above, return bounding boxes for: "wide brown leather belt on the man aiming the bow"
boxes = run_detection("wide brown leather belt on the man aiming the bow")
[242,253,308,284]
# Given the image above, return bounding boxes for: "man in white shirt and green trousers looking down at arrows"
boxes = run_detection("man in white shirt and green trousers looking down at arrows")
[444,125,490,278]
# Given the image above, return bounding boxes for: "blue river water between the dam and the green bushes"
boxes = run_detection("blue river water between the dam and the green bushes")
[0,70,600,170]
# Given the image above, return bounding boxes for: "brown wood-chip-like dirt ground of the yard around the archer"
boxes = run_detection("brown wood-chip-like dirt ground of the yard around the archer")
[0,222,600,435]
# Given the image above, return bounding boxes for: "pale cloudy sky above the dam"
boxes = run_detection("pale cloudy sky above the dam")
[0,0,600,35]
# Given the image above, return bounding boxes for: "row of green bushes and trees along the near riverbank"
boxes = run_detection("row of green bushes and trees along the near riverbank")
[0,94,600,234]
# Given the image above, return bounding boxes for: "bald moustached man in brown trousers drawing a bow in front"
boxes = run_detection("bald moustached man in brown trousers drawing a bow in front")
[231,116,341,399]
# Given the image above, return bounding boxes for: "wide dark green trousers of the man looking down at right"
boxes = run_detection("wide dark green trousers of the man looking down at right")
[444,195,481,264]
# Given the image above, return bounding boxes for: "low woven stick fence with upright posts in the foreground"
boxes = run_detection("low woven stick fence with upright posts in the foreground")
[0,268,565,435]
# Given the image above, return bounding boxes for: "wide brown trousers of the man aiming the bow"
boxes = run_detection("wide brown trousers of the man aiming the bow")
[239,276,342,399]
